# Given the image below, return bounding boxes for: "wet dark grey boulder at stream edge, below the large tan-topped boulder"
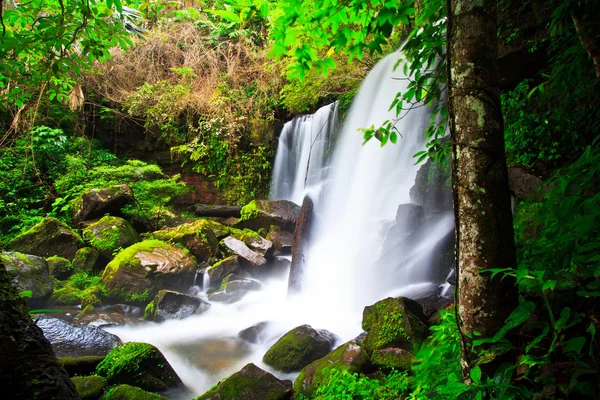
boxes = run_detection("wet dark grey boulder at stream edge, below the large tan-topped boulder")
[144,290,210,322]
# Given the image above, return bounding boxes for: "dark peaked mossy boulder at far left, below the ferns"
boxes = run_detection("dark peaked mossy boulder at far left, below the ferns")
[8,218,84,260]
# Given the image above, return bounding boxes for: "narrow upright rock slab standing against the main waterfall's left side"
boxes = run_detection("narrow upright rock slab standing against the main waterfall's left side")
[288,196,314,292]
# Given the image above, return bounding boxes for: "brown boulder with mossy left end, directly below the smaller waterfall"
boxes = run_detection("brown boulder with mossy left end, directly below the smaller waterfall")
[236,200,300,232]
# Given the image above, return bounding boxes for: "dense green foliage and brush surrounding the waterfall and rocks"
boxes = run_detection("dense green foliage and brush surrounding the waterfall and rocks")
[0,0,600,399]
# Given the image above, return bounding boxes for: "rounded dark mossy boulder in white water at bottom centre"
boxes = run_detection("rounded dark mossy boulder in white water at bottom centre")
[263,325,335,372]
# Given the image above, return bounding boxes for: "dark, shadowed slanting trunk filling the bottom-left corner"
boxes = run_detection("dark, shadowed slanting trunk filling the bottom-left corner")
[0,262,80,400]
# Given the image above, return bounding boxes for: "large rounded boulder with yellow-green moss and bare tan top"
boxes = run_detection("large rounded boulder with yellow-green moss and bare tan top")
[102,240,197,303]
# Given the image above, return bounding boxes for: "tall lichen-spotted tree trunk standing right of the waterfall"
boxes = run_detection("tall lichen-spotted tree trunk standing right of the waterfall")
[447,0,517,381]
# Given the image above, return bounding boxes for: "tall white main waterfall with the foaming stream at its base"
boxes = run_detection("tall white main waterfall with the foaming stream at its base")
[109,53,452,398]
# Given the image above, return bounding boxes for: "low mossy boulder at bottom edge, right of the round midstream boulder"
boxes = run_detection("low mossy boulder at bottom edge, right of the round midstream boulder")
[294,341,372,399]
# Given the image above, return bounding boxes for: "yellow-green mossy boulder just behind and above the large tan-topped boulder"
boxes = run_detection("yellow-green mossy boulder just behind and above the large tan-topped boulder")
[149,219,219,263]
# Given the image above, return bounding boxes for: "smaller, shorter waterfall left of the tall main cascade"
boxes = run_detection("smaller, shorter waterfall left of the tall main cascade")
[271,102,338,204]
